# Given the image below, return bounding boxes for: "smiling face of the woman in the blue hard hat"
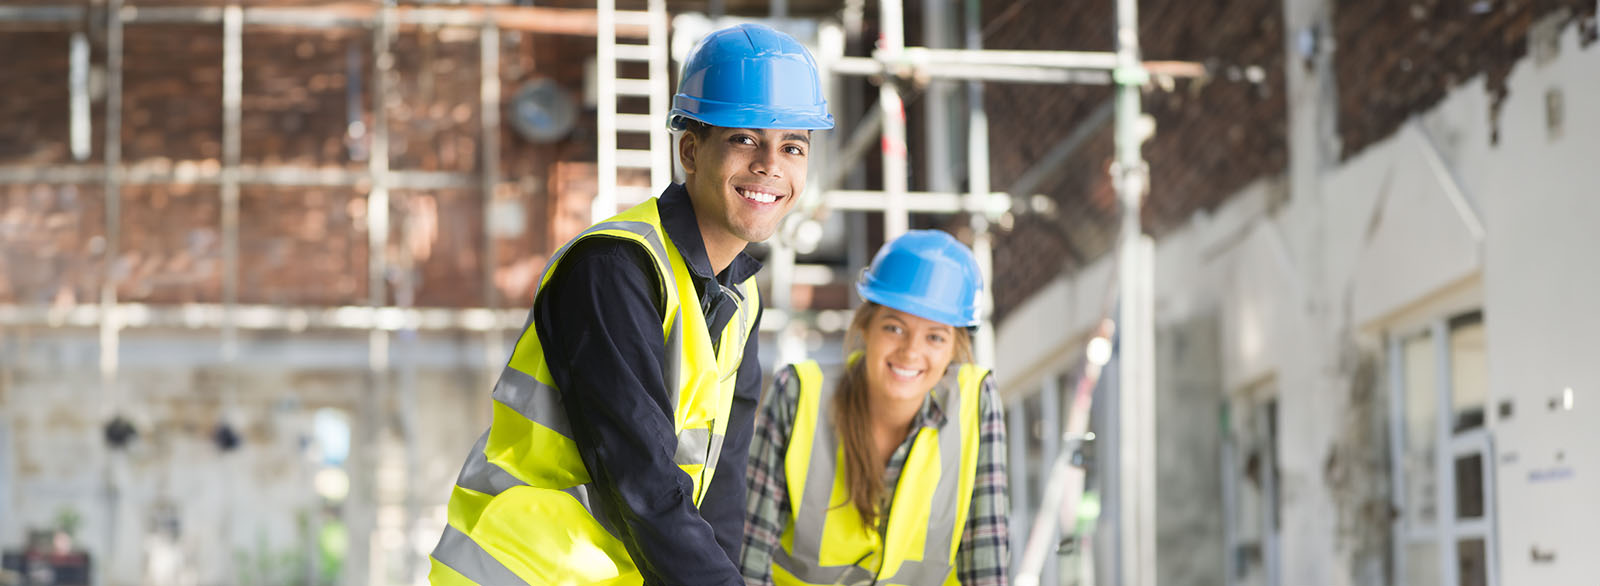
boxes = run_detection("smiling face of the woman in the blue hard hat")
[862,307,955,402]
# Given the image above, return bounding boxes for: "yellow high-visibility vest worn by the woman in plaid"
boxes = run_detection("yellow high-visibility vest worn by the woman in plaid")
[773,362,989,586]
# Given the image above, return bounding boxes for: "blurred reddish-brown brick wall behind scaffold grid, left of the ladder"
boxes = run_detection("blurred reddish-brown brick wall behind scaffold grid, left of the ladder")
[0,11,594,307]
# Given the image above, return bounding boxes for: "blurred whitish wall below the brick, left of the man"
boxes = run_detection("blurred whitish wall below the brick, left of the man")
[0,330,492,586]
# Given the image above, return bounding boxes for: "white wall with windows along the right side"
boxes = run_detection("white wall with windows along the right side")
[997,17,1600,584]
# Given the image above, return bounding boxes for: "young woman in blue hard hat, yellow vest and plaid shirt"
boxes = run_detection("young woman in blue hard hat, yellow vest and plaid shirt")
[739,231,1010,586]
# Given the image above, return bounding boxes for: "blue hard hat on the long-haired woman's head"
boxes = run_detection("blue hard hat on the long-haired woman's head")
[856,231,984,328]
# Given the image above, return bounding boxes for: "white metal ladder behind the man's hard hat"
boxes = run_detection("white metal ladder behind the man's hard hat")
[590,0,672,221]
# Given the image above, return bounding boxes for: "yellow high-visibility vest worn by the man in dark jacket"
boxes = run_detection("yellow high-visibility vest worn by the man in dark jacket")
[429,199,762,586]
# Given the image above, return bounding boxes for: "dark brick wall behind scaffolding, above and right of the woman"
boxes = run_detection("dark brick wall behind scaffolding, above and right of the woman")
[907,0,1286,317]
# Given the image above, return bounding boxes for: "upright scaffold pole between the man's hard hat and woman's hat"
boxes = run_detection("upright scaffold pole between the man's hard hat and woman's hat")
[878,0,910,242]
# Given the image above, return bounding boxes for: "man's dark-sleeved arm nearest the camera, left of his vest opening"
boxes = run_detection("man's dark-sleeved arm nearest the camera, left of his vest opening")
[534,240,739,586]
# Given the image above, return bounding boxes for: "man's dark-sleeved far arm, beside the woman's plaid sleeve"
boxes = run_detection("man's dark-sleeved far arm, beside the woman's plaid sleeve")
[701,304,762,562]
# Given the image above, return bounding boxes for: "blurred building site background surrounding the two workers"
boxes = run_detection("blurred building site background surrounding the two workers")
[0,0,1600,586]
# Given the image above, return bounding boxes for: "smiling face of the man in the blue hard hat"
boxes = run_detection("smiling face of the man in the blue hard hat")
[678,126,811,250]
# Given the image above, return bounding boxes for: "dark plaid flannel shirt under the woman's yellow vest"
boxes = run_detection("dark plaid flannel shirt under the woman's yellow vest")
[739,363,1011,586]
